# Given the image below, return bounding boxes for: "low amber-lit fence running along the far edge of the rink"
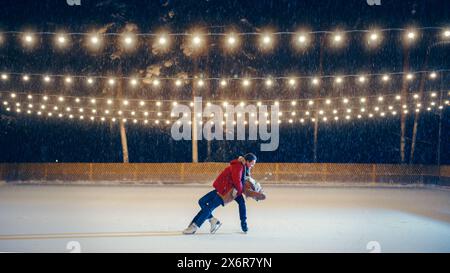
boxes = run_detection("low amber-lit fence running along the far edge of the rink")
[0,162,450,185]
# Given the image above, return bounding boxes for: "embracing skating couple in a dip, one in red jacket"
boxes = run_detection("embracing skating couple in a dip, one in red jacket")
[183,153,265,234]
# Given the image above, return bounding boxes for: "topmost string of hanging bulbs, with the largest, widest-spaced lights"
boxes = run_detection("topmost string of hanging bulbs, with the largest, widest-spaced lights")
[0,27,450,50]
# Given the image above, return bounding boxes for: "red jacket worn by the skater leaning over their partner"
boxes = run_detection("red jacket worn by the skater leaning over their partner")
[213,159,245,203]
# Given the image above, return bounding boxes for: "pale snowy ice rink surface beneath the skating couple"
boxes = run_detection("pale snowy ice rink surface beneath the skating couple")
[0,184,450,253]
